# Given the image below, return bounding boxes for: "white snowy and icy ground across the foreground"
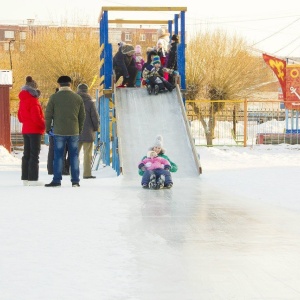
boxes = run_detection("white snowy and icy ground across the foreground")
[0,144,300,300]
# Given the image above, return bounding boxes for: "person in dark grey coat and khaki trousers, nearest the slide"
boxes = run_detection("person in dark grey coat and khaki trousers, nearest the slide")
[77,83,100,179]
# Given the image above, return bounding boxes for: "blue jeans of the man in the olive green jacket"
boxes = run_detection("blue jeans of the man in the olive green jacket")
[53,135,79,183]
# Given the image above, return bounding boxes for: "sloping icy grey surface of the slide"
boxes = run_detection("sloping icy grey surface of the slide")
[115,86,201,178]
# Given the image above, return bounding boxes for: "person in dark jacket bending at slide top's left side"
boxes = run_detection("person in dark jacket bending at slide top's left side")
[113,45,138,87]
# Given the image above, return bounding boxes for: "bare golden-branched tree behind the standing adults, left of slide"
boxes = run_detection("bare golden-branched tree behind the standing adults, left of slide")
[7,26,101,112]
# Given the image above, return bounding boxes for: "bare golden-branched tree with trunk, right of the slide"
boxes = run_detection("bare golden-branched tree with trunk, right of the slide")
[186,31,271,145]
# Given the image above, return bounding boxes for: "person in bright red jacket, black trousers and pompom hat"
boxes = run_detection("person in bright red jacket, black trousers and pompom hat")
[18,76,45,186]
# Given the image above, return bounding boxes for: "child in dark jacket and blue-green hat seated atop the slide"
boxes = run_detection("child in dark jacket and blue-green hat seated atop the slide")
[143,55,175,95]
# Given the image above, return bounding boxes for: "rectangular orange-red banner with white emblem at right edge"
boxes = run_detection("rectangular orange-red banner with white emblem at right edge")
[284,65,300,110]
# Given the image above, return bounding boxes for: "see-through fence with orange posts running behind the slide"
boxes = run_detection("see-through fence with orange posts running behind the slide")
[11,100,300,146]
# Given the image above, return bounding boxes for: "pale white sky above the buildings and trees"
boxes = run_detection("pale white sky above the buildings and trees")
[0,0,300,57]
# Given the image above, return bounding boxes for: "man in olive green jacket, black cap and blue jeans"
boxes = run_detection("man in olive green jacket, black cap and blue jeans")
[45,76,85,187]
